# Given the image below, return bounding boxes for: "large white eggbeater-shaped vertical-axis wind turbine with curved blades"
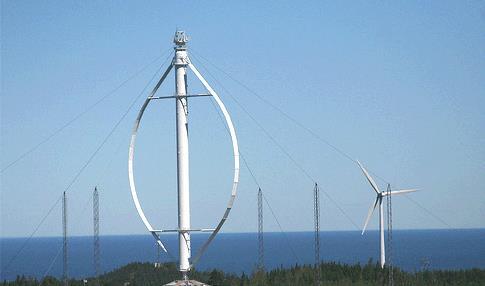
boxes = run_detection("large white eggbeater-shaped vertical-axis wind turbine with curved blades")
[128,31,239,280]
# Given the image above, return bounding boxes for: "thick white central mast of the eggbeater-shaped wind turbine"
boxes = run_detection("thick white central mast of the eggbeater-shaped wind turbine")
[173,31,190,280]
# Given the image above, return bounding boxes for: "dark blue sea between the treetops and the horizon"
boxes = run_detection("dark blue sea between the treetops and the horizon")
[0,229,485,281]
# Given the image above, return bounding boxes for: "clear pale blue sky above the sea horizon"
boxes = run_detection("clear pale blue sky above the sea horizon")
[0,1,485,237]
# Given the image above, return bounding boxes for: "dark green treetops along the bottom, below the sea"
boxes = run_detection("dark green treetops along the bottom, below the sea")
[2,261,485,286]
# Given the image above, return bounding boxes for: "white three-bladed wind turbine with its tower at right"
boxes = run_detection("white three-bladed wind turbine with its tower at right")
[357,161,417,268]
